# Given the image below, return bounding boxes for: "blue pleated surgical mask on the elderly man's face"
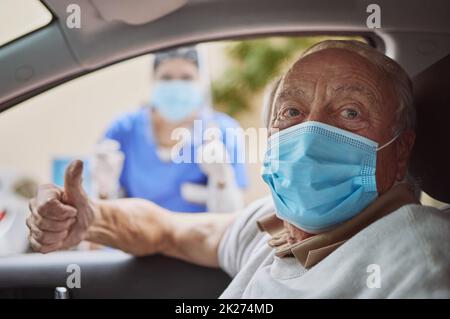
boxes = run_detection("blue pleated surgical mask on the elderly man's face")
[262,121,398,233]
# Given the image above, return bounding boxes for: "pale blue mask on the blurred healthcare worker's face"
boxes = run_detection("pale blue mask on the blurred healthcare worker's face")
[150,80,203,123]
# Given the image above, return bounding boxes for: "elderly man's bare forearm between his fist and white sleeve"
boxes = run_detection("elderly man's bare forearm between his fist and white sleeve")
[86,198,236,267]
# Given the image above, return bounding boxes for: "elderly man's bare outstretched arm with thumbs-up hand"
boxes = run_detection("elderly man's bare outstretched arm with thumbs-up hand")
[27,161,236,267]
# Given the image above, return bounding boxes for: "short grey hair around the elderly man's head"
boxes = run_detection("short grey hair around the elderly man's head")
[263,40,416,133]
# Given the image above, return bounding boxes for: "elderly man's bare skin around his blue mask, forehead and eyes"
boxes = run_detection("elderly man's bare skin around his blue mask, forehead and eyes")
[270,49,414,198]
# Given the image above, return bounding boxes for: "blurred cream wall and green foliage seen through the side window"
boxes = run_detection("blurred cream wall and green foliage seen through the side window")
[0,36,362,202]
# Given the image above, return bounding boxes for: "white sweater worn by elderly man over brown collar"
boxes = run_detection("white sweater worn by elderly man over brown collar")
[218,197,450,298]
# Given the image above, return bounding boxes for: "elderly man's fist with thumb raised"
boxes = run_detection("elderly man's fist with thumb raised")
[27,161,96,253]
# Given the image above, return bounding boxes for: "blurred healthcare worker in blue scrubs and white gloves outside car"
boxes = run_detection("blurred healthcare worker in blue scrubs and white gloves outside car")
[94,47,247,212]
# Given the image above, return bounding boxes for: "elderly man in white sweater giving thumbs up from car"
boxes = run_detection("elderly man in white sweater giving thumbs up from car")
[27,41,450,298]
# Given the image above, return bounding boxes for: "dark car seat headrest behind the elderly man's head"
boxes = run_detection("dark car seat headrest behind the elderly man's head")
[411,54,450,203]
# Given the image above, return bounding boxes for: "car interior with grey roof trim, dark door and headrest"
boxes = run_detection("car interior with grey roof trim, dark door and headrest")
[0,0,450,298]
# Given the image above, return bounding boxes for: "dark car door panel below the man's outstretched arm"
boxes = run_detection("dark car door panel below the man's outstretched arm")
[0,250,230,298]
